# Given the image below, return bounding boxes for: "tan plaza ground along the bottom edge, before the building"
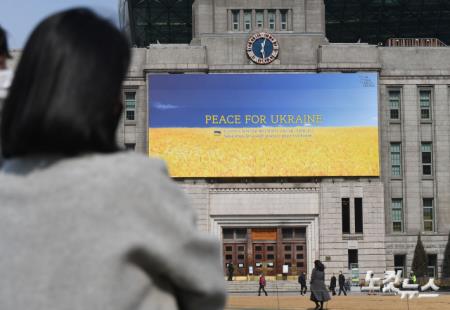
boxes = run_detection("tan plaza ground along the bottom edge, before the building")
[225,295,450,310]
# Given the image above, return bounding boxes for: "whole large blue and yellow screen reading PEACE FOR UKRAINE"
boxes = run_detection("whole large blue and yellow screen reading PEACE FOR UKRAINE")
[148,73,379,177]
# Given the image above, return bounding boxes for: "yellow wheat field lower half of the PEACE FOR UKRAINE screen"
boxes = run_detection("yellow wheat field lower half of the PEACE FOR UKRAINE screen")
[149,127,379,177]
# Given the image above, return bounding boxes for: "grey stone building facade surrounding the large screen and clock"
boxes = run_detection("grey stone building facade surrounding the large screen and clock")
[118,0,450,276]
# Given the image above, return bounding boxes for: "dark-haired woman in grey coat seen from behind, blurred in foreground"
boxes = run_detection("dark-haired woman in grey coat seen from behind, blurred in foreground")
[0,9,225,310]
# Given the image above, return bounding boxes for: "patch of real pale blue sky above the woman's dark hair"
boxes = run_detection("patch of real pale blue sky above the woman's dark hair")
[0,0,119,49]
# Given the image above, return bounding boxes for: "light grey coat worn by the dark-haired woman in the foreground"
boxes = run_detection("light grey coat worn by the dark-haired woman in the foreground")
[0,152,225,310]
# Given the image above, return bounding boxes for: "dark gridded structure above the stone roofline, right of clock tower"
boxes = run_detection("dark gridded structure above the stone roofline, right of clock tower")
[325,0,450,45]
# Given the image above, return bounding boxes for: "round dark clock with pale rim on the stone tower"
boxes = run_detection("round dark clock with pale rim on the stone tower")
[247,32,280,65]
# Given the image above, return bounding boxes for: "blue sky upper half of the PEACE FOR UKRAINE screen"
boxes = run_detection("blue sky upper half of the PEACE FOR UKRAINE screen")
[149,73,378,128]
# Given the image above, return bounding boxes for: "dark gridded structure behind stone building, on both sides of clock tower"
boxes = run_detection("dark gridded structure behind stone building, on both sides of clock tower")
[119,0,450,47]
